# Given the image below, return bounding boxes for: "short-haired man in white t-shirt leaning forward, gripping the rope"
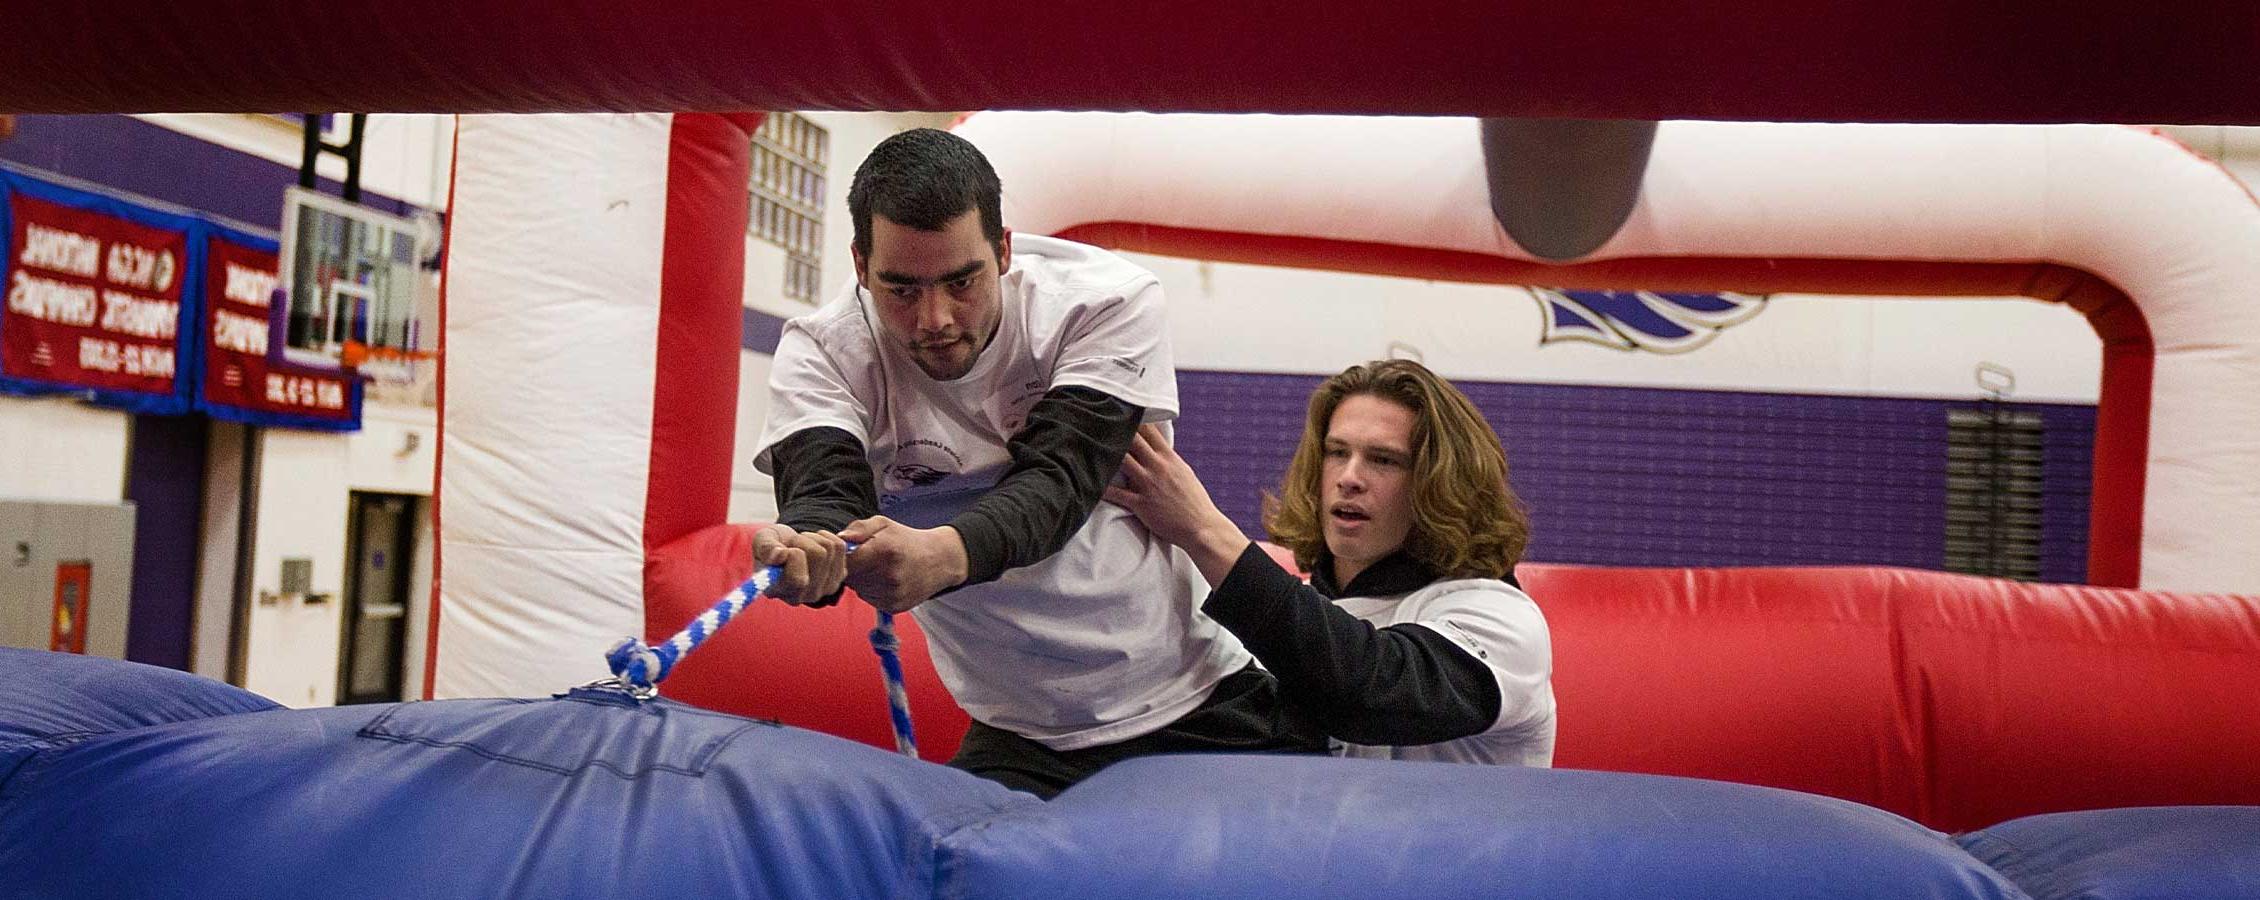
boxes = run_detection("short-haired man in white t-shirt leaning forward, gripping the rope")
[755,129,1324,796]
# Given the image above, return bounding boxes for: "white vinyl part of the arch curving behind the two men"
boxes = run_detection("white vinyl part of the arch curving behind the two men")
[958,113,2260,592]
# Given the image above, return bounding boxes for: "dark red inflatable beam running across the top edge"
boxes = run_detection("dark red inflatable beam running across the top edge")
[0,0,2260,124]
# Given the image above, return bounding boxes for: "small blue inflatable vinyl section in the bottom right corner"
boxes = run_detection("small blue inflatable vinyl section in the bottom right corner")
[1957,807,2260,900]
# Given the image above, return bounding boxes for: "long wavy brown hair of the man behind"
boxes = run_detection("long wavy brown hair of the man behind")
[1263,360,1530,579]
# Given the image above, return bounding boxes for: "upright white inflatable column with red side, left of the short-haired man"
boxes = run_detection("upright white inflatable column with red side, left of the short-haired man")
[425,115,748,696]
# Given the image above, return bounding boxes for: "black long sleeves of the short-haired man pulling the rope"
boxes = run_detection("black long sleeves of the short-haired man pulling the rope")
[771,384,1146,602]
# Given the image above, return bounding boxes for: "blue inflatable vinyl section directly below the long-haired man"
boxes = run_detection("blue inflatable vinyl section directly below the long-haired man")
[940,755,2025,900]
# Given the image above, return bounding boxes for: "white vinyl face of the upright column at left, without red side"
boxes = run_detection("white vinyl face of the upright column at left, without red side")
[434,115,673,696]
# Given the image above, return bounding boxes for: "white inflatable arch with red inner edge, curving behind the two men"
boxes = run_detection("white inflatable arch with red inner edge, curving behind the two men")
[958,113,2260,592]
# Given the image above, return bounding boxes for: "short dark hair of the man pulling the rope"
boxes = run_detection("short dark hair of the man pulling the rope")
[848,129,1003,256]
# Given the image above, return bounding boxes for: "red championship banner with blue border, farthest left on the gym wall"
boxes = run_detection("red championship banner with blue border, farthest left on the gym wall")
[0,170,201,414]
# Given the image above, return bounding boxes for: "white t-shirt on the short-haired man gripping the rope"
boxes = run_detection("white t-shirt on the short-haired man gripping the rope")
[755,235,1250,751]
